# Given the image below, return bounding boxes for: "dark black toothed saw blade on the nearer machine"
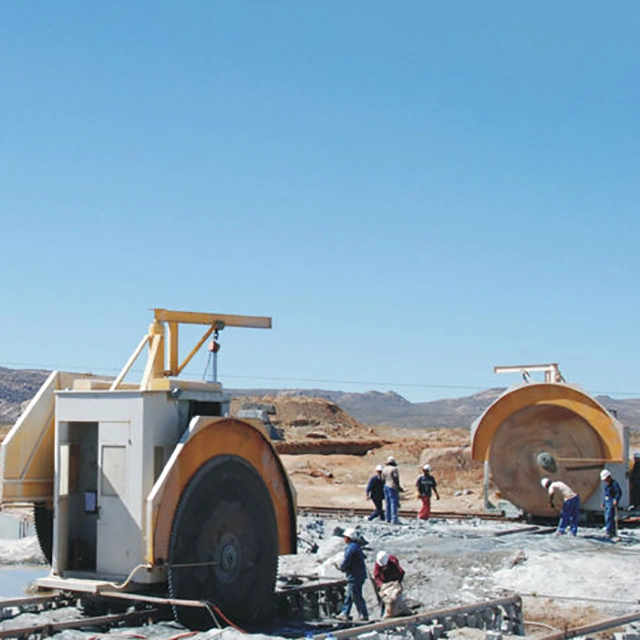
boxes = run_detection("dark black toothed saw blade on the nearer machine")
[168,455,278,629]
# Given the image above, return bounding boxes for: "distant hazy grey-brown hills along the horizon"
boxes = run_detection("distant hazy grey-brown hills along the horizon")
[0,367,640,430]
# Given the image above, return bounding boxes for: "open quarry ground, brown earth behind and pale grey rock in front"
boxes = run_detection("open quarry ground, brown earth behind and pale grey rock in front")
[0,399,640,638]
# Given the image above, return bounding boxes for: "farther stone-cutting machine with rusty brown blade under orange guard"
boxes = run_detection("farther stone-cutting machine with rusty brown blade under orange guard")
[471,363,629,517]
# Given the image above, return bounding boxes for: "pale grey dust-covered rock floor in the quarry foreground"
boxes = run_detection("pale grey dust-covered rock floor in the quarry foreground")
[0,516,640,640]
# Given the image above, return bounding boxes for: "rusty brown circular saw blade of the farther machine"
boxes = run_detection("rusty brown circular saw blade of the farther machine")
[489,405,603,516]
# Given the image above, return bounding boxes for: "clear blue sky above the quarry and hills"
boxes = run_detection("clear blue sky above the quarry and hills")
[0,0,640,401]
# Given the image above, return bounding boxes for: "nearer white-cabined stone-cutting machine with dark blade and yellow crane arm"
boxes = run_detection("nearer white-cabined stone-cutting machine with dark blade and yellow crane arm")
[0,309,296,628]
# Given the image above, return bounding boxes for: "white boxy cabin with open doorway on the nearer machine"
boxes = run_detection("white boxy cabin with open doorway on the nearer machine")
[50,381,230,583]
